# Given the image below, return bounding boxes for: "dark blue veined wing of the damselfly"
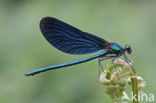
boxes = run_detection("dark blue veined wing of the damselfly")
[40,17,109,54]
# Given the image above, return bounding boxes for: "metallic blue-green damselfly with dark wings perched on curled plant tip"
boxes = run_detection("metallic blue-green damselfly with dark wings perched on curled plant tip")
[25,17,132,76]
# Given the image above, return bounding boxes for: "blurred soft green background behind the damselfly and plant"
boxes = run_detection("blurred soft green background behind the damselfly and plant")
[0,0,156,103]
